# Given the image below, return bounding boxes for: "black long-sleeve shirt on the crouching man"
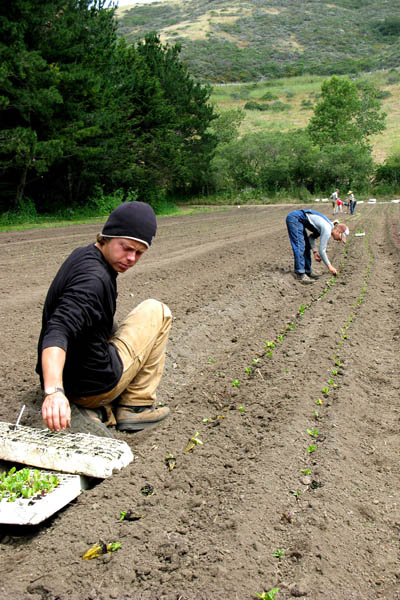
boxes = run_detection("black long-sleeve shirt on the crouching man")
[36,244,122,397]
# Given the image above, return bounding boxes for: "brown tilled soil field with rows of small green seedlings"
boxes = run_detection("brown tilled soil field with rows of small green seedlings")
[0,204,400,600]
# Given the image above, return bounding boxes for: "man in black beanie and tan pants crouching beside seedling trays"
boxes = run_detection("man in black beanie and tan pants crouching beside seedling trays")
[36,202,172,437]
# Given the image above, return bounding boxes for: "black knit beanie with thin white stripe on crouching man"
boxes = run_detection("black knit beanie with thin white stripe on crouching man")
[101,200,157,247]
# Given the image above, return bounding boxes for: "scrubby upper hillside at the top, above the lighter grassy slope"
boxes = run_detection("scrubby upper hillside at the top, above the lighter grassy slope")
[117,0,400,83]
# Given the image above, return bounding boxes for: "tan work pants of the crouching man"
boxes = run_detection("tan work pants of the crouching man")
[71,299,172,424]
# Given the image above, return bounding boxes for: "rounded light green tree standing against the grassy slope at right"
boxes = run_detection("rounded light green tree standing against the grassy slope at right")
[307,76,385,147]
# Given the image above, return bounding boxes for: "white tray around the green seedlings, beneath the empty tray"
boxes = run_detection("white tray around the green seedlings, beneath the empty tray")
[0,471,87,525]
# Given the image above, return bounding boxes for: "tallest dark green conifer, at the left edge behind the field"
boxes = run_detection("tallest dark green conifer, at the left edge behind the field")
[0,0,119,208]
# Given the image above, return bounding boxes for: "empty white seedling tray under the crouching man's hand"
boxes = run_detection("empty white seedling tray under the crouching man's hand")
[0,422,133,479]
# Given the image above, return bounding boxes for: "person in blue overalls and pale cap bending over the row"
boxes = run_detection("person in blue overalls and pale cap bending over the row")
[286,210,349,284]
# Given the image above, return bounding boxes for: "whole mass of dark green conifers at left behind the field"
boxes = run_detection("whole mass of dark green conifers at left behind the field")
[0,6,216,212]
